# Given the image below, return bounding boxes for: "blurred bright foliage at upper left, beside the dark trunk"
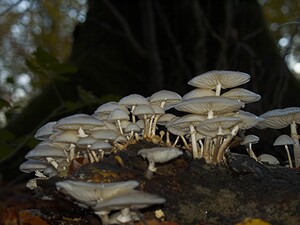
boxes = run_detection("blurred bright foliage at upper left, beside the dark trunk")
[0,0,87,118]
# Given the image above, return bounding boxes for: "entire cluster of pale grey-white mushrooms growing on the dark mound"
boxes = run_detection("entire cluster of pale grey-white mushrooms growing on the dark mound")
[20,70,300,224]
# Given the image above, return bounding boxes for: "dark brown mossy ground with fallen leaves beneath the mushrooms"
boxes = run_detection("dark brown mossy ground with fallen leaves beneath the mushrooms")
[0,142,300,225]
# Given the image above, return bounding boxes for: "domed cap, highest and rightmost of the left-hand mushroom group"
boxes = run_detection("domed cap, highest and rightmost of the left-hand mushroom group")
[149,90,182,108]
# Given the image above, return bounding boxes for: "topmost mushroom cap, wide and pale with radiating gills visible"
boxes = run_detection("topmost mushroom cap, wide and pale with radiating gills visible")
[188,70,250,89]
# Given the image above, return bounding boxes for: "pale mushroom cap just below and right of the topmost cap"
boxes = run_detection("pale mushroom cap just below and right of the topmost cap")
[221,88,261,104]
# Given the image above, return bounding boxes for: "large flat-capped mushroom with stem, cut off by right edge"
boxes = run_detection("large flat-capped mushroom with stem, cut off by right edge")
[257,107,300,168]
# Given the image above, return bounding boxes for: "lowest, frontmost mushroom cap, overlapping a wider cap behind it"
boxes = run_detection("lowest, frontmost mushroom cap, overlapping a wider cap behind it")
[93,190,166,211]
